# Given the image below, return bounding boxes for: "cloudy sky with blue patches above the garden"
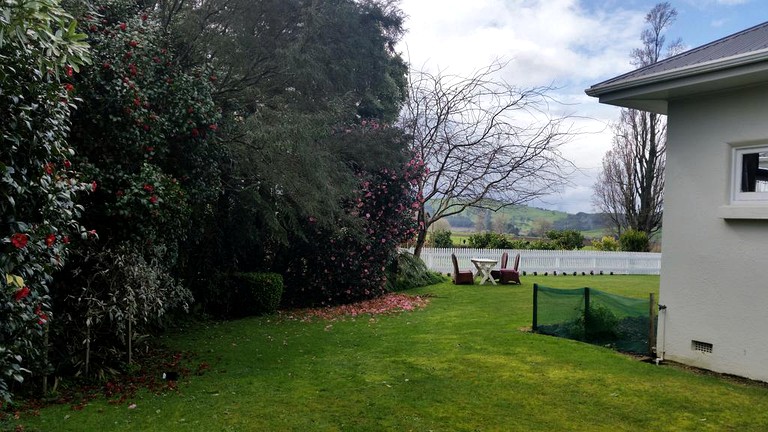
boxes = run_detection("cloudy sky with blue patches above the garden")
[397,0,768,213]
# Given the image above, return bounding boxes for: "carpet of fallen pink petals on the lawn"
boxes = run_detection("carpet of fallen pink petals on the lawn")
[280,293,429,322]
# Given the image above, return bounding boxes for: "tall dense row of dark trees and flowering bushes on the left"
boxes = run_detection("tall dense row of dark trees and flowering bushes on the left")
[0,0,423,400]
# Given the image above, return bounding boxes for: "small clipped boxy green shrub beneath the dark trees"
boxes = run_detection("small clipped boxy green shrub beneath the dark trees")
[229,273,283,316]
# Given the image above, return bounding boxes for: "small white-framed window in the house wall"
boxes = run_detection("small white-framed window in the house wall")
[731,146,768,201]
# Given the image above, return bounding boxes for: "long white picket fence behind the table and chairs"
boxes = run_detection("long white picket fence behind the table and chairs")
[409,248,661,275]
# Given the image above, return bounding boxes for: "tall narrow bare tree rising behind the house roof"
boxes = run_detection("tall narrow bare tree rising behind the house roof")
[593,2,682,235]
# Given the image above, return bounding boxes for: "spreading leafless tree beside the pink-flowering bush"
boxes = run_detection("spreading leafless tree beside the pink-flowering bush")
[400,61,572,256]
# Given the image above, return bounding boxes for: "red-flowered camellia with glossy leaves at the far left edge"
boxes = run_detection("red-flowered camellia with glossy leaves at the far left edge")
[0,0,95,400]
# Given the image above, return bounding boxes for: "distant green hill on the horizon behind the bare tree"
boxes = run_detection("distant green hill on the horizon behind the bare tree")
[427,203,609,237]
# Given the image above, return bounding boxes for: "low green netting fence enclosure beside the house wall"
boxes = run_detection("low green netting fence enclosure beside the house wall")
[533,284,656,355]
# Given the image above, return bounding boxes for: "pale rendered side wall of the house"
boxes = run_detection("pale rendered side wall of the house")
[657,86,768,381]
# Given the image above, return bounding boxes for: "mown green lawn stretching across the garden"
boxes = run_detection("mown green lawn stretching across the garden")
[7,276,768,431]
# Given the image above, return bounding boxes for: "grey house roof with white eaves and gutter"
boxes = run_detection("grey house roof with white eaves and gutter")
[586,22,768,113]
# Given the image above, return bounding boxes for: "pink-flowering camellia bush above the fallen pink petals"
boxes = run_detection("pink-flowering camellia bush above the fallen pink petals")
[283,123,424,306]
